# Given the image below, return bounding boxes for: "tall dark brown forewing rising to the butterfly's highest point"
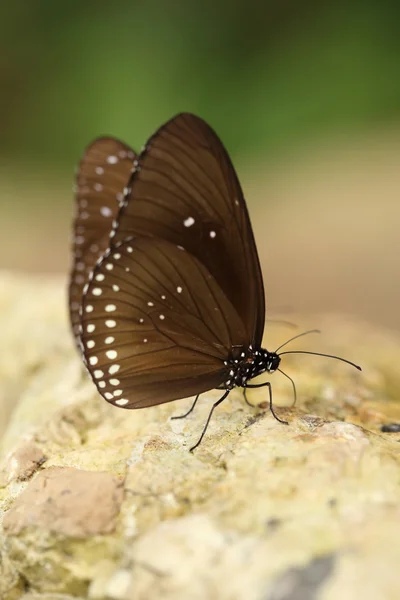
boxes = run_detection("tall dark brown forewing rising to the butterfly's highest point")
[113,114,265,347]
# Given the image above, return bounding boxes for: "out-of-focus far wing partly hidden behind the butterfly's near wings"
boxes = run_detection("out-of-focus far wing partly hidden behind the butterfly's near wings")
[69,137,135,340]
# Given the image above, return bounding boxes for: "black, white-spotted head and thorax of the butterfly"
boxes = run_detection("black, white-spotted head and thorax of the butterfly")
[223,347,281,389]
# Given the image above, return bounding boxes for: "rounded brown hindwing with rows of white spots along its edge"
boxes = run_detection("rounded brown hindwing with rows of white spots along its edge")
[81,238,249,408]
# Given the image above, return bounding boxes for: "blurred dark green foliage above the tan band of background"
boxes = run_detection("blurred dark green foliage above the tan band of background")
[0,0,400,172]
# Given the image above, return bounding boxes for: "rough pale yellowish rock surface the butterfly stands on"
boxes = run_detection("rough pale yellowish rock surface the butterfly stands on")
[0,275,400,600]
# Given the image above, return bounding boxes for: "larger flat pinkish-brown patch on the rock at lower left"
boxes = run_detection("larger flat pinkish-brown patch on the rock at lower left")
[3,467,124,537]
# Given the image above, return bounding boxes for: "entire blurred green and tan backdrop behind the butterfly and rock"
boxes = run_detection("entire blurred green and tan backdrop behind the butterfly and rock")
[0,0,400,327]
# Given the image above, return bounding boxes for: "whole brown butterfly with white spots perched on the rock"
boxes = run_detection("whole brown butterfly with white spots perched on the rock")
[70,113,360,451]
